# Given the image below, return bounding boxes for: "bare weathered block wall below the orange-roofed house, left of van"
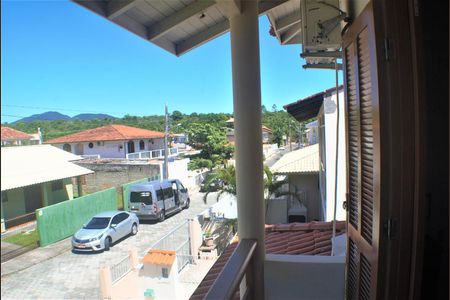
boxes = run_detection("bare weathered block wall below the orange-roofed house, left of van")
[77,161,161,194]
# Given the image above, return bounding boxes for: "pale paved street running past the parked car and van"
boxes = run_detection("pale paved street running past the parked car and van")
[1,193,213,299]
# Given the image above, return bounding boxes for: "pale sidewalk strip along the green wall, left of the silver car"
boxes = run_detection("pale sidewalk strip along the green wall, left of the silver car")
[1,237,72,277]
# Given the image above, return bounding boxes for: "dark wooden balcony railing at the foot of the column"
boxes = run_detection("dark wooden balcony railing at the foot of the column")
[205,239,257,300]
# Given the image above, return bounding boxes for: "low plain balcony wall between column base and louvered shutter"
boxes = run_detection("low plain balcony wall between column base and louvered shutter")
[264,254,345,300]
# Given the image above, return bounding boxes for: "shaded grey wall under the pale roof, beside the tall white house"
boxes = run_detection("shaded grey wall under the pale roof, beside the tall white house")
[288,174,323,222]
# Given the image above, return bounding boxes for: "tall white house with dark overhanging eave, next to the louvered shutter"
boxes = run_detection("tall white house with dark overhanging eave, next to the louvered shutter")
[285,86,347,221]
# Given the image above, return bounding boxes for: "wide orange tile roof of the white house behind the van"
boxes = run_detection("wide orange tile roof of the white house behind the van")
[45,125,164,144]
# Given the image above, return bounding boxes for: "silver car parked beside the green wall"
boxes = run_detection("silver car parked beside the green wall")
[72,211,139,251]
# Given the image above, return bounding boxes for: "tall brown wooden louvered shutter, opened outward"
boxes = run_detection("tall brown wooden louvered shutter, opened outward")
[343,3,380,300]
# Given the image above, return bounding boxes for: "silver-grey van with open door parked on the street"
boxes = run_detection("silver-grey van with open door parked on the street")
[128,179,190,221]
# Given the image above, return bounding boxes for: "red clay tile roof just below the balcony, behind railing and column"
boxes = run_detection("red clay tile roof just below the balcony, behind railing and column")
[190,221,346,300]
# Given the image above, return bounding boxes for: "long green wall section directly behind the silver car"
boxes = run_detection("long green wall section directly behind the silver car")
[36,188,117,247]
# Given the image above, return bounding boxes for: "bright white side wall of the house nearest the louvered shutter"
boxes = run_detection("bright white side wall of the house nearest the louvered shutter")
[323,91,347,221]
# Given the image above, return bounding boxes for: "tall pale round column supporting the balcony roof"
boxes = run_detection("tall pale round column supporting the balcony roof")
[230,0,265,299]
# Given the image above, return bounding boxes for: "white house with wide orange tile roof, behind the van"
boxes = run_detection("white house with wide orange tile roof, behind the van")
[45,124,164,158]
